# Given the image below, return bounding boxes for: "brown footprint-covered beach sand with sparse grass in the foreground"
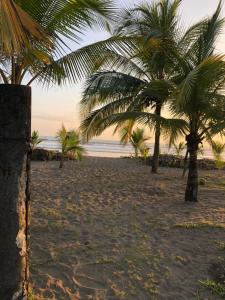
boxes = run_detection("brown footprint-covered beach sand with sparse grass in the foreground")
[30,157,225,300]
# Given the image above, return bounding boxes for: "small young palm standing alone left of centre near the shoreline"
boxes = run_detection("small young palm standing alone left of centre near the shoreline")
[57,125,85,168]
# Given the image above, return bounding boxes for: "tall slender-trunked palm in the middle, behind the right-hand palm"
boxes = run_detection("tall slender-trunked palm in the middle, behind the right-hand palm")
[81,0,180,173]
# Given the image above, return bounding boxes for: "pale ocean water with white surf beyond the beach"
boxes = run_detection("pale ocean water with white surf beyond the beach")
[38,136,218,159]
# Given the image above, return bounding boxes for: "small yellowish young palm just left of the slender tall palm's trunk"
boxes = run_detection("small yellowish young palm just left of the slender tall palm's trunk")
[120,127,148,158]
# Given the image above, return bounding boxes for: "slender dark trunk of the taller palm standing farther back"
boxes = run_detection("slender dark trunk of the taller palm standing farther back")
[152,103,161,174]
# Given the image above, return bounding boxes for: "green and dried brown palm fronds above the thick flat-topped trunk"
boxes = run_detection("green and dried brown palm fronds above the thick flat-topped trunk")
[0,0,117,85]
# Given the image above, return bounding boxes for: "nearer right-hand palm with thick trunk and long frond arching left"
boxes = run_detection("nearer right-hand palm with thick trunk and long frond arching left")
[83,2,225,202]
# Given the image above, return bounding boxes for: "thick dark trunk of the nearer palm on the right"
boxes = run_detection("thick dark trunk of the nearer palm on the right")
[185,133,199,202]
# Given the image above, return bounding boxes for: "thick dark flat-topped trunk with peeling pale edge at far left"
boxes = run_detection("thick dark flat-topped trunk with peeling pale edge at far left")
[0,85,31,300]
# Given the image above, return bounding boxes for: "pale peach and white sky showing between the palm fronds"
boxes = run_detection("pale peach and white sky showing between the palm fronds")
[32,0,225,139]
